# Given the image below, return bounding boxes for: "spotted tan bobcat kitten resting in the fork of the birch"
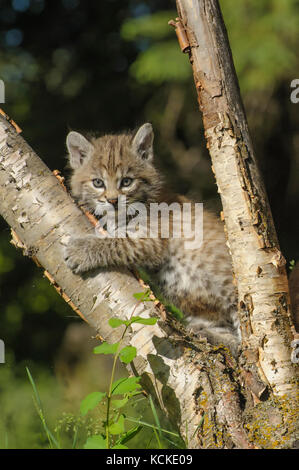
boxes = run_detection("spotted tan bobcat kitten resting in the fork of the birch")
[65,123,240,353]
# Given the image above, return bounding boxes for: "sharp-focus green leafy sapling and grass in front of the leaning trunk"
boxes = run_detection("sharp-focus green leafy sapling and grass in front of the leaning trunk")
[26,290,184,449]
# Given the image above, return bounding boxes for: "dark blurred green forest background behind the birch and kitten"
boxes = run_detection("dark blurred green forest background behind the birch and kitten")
[0,0,299,448]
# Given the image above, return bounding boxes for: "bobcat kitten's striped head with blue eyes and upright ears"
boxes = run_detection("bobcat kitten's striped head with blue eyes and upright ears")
[67,124,162,215]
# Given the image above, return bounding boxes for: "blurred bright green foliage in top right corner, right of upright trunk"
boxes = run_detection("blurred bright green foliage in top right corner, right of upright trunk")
[221,0,299,92]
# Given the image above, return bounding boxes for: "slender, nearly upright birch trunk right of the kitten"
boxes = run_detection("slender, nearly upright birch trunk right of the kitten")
[177,0,298,398]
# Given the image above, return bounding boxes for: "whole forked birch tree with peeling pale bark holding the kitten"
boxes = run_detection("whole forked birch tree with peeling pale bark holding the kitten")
[0,0,298,448]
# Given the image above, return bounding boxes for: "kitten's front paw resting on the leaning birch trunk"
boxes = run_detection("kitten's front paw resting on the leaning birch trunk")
[63,237,93,274]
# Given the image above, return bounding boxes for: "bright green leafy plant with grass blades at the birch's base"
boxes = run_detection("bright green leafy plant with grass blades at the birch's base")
[20,291,182,449]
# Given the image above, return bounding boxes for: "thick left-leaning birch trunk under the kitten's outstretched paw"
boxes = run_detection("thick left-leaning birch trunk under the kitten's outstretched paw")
[0,116,251,448]
